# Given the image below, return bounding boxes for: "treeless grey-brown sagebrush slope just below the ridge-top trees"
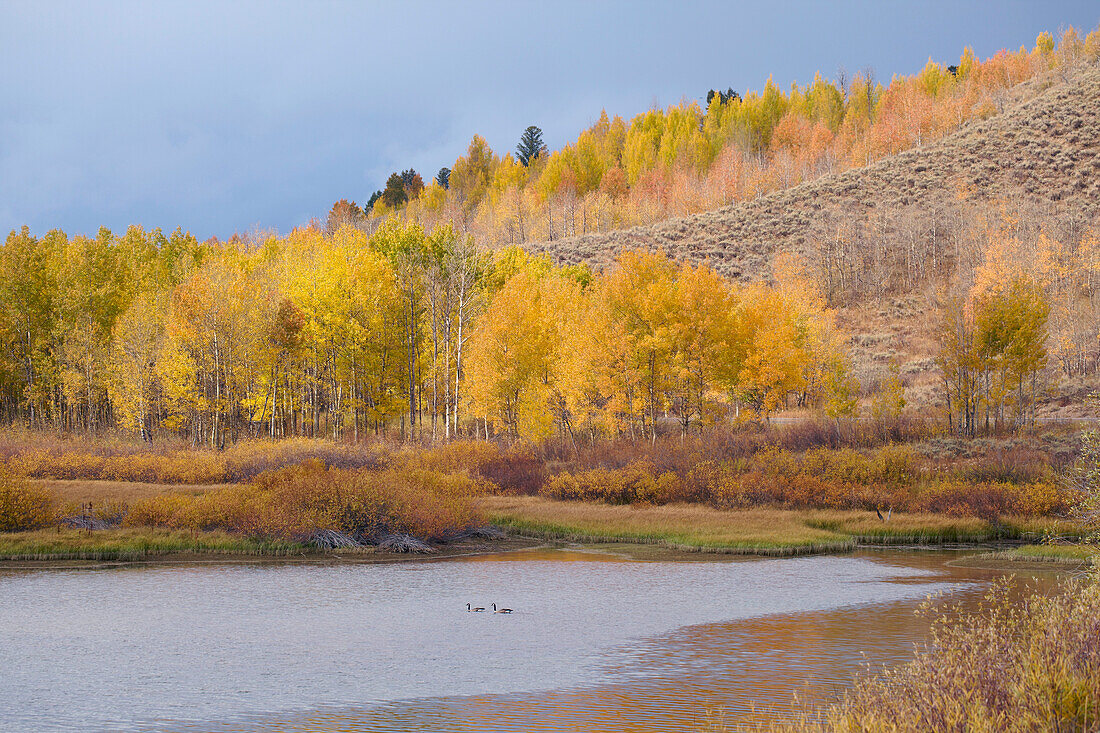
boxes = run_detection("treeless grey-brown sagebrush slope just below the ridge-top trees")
[527,66,1100,280]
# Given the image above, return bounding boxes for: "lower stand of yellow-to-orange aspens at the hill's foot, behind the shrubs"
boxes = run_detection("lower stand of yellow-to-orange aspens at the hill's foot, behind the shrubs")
[0,220,858,447]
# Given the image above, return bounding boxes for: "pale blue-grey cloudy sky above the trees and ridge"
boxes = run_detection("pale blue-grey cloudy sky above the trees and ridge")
[0,0,1100,239]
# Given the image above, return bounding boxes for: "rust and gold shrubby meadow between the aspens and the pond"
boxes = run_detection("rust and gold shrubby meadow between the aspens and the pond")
[0,420,1079,558]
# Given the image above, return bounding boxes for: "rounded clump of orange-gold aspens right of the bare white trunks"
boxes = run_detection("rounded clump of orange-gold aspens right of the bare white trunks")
[468,251,858,441]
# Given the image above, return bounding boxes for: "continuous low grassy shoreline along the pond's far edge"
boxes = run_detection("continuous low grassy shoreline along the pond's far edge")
[0,495,1082,570]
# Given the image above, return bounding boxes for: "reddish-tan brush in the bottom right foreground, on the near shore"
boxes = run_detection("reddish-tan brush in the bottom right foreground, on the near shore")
[782,575,1100,733]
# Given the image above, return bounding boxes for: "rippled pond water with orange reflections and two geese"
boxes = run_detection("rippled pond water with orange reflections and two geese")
[0,550,1047,731]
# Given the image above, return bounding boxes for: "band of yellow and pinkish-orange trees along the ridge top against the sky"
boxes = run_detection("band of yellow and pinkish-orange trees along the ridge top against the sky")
[329,29,1100,248]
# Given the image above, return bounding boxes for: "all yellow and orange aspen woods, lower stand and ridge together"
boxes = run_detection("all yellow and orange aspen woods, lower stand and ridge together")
[0,30,1100,450]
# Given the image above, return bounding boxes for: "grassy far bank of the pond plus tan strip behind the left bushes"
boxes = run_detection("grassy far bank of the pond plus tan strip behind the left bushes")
[0,480,1081,567]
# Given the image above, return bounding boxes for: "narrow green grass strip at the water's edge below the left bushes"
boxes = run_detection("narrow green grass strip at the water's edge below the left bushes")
[0,527,307,560]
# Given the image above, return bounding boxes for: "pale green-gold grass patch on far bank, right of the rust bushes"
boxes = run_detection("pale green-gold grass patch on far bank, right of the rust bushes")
[480,496,1064,555]
